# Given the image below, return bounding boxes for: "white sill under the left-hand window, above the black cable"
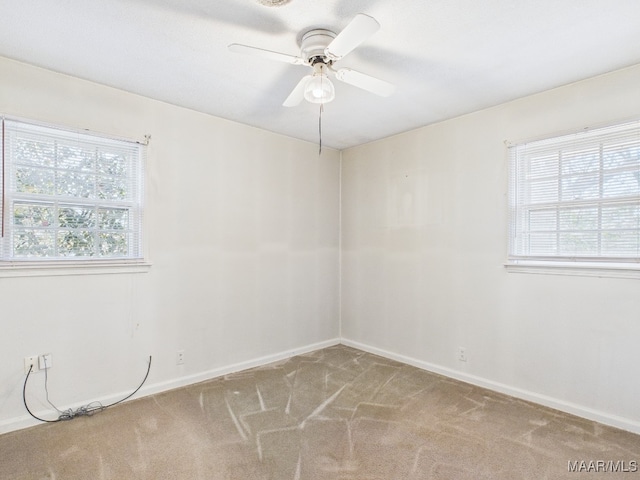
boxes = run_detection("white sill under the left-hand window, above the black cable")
[0,261,151,278]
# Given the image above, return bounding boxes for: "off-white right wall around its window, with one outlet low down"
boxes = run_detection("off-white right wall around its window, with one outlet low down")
[342,62,640,433]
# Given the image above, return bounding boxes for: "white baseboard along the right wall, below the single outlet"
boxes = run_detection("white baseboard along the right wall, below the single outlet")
[341,338,640,434]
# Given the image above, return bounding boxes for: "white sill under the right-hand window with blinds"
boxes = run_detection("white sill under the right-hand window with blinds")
[504,260,640,279]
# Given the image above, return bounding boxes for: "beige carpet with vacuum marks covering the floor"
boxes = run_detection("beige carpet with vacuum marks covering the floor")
[0,346,640,480]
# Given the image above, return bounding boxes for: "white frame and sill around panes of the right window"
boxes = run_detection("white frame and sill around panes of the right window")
[505,119,640,278]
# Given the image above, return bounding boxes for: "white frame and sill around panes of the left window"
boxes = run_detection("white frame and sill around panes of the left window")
[0,115,151,277]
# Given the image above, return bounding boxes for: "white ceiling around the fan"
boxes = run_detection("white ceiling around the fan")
[0,0,640,149]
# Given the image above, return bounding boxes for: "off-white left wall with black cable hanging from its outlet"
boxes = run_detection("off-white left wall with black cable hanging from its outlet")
[0,58,340,432]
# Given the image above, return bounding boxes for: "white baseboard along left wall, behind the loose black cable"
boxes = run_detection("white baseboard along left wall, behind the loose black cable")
[0,338,340,434]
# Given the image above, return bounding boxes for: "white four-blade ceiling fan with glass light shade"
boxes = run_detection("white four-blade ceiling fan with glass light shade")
[229,13,395,107]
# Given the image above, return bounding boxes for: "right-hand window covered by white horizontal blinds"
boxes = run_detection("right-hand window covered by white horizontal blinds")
[509,121,640,265]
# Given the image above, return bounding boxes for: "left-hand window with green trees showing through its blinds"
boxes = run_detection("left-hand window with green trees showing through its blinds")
[0,119,144,266]
